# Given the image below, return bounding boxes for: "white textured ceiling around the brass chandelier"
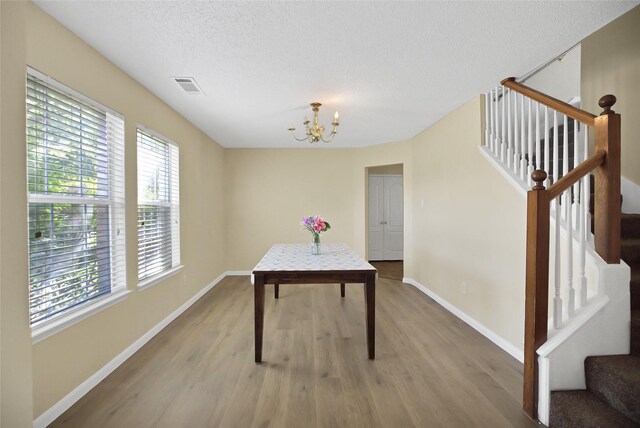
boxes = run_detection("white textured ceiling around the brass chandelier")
[36,1,638,147]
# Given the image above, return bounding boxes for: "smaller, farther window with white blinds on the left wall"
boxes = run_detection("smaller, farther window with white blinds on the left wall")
[138,127,180,286]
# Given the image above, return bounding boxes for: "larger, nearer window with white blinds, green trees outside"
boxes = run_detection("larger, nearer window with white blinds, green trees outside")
[26,69,126,327]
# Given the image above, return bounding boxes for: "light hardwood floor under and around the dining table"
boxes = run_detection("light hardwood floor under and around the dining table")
[52,276,536,428]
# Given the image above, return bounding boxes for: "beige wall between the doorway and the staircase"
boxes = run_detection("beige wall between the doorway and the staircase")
[405,97,526,349]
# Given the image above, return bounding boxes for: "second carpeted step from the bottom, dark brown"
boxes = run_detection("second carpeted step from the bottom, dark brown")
[584,355,640,423]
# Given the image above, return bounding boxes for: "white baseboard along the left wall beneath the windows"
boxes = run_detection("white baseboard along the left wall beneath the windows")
[33,272,231,428]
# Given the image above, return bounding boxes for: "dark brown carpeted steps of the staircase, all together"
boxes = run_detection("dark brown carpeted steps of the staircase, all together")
[549,176,640,428]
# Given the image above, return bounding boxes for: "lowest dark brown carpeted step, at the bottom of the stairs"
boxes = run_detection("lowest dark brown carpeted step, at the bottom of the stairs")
[549,390,637,428]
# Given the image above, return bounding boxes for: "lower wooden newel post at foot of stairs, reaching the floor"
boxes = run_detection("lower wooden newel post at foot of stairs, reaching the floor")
[522,170,550,420]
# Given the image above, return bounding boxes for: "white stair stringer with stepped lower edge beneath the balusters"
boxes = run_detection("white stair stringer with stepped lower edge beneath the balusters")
[537,255,631,425]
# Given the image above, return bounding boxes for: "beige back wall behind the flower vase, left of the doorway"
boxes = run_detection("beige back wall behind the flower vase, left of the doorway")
[225,148,359,271]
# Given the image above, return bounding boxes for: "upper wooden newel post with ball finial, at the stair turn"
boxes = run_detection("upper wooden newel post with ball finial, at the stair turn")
[594,95,621,263]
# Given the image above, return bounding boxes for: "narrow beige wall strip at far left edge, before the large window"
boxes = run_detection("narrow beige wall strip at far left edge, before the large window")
[0,2,33,427]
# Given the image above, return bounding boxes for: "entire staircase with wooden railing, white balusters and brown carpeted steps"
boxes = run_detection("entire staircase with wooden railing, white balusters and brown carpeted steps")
[481,78,640,427]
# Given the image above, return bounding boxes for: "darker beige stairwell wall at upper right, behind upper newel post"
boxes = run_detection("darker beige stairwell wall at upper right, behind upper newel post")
[581,6,640,185]
